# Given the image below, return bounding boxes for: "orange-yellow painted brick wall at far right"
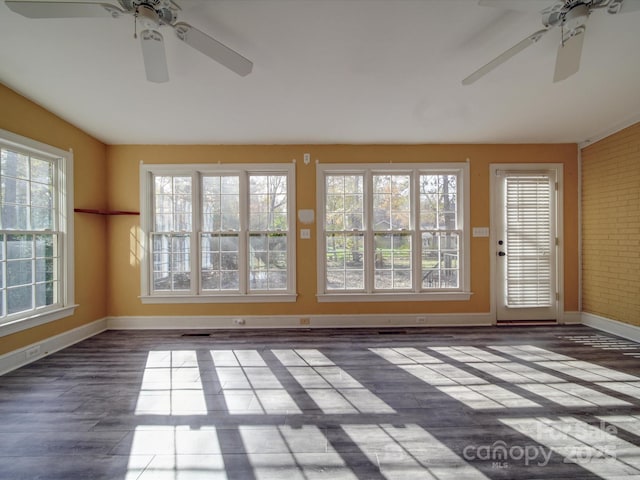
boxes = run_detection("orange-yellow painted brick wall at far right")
[582,123,640,325]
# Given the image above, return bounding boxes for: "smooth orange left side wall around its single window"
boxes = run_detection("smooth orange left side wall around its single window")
[0,84,108,355]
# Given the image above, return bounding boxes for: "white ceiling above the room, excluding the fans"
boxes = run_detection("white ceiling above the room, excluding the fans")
[0,0,640,144]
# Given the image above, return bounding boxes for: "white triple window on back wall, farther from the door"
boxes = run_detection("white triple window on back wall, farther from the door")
[141,164,295,303]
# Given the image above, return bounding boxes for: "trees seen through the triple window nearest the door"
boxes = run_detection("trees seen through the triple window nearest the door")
[324,171,460,291]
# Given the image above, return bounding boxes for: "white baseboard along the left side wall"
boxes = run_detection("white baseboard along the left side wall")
[0,318,107,375]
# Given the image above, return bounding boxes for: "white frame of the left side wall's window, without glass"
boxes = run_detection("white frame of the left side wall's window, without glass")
[0,129,77,337]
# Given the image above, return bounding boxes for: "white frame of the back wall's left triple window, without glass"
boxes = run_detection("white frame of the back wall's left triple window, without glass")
[140,163,297,304]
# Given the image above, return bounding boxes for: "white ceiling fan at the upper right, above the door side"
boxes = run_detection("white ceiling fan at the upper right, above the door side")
[462,0,640,85]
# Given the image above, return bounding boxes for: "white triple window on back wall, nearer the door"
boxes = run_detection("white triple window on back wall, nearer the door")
[317,163,469,301]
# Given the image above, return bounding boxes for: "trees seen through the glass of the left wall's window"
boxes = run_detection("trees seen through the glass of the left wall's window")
[0,146,60,318]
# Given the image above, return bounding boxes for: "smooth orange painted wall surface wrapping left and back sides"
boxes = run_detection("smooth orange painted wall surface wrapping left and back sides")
[0,84,579,355]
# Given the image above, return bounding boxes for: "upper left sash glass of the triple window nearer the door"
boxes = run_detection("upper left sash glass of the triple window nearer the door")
[325,175,364,231]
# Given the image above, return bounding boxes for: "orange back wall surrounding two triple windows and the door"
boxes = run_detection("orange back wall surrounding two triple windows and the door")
[107,144,579,316]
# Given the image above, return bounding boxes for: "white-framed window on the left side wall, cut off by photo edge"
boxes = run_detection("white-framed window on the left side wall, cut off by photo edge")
[0,126,75,333]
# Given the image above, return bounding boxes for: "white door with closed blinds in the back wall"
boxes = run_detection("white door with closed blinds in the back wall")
[492,166,558,323]
